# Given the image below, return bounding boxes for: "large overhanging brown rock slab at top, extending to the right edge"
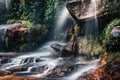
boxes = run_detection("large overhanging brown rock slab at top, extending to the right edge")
[67,0,120,21]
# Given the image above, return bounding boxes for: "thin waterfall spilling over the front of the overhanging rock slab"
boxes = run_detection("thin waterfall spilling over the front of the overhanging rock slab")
[84,0,99,38]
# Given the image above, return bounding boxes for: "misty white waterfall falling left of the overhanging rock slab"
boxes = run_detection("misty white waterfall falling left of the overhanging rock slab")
[54,6,69,41]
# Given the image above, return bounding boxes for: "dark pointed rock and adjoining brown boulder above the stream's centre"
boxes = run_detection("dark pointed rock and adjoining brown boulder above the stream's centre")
[51,40,86,57]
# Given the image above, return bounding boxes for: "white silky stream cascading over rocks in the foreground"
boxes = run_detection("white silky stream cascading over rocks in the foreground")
[14,41,100,80]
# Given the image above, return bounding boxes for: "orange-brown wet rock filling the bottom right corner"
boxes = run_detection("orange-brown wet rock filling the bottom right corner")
[79,55,120,80]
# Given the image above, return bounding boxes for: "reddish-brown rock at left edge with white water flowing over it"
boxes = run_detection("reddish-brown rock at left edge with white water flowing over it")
[0,23,28,42]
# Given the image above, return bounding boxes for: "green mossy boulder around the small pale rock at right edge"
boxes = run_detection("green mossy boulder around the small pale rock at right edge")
[103,19,120,51]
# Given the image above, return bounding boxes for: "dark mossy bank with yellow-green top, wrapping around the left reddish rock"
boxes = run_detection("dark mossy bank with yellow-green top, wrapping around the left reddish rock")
[4,19,48,51]
